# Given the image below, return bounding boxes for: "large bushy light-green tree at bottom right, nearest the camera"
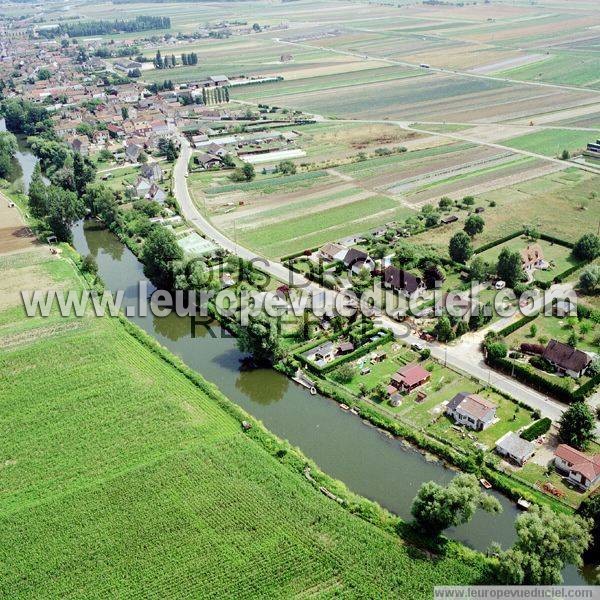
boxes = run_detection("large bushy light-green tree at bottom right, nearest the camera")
[496,505,592,585]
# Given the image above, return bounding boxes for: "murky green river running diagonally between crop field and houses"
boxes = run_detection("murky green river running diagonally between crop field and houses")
[0,130,591,584]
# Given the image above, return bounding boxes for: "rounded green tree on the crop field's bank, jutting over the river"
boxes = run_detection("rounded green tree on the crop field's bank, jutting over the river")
[411,474,502,536]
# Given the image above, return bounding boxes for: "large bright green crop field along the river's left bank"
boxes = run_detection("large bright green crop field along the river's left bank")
[0,247,481,599]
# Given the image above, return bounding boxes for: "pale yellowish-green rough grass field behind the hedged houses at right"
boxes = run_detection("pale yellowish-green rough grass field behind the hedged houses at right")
[413,169,600,252]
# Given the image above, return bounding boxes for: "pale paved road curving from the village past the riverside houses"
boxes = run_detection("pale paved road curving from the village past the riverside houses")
[173,138,580,420]
